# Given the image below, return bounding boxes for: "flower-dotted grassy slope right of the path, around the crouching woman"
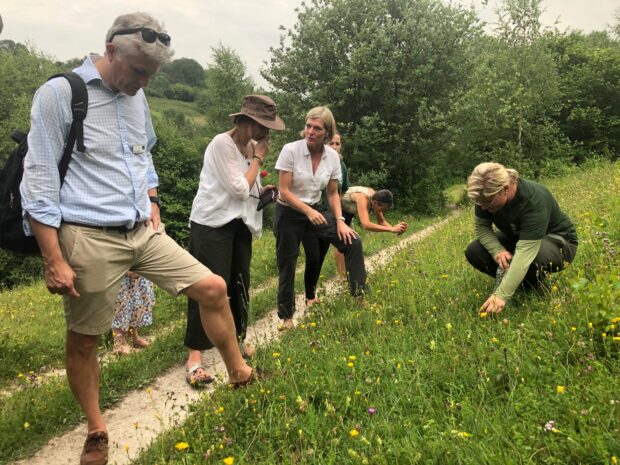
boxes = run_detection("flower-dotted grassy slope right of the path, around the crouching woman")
[137,164,620,465]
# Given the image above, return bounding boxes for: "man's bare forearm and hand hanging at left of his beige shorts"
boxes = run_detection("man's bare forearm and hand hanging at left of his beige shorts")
[30,219,80,297]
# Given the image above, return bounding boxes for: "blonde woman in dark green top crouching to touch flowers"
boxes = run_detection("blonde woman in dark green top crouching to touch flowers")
[465,163,577,313]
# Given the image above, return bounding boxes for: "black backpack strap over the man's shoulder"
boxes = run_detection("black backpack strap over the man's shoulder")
[48,71,88,186]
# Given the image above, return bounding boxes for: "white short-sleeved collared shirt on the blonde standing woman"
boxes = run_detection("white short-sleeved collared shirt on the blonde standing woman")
[276,139,342,205]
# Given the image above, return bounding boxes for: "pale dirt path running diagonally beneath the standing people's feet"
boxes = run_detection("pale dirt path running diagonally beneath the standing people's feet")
[8,212,455,465]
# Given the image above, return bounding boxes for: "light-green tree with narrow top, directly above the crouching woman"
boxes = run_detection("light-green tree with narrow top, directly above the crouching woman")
[451,0,570,176]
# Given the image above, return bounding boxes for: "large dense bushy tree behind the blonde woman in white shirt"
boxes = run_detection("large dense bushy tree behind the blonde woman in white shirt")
[262,0,480,211]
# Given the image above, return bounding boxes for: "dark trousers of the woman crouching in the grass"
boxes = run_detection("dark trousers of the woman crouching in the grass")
[465,231,577,287]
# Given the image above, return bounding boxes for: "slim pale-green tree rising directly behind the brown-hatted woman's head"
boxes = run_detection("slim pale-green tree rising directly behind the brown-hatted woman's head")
[197,44,254,134]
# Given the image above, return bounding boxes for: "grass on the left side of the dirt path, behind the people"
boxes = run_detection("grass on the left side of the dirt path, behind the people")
[0,208,434,463]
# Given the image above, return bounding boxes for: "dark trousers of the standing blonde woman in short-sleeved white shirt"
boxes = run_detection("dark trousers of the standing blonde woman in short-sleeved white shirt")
[274,203,366,319]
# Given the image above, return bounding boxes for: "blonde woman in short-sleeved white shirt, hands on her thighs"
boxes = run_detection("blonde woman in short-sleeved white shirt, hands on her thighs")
[275,107,366,329]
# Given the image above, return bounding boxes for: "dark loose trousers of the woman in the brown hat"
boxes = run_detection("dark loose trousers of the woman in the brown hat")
[185,219,252,350]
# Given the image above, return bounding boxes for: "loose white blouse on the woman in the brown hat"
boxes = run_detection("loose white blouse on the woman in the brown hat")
[190,133,263,237]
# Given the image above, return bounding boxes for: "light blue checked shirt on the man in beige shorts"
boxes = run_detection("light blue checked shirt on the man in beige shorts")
[20,57,158,234]
